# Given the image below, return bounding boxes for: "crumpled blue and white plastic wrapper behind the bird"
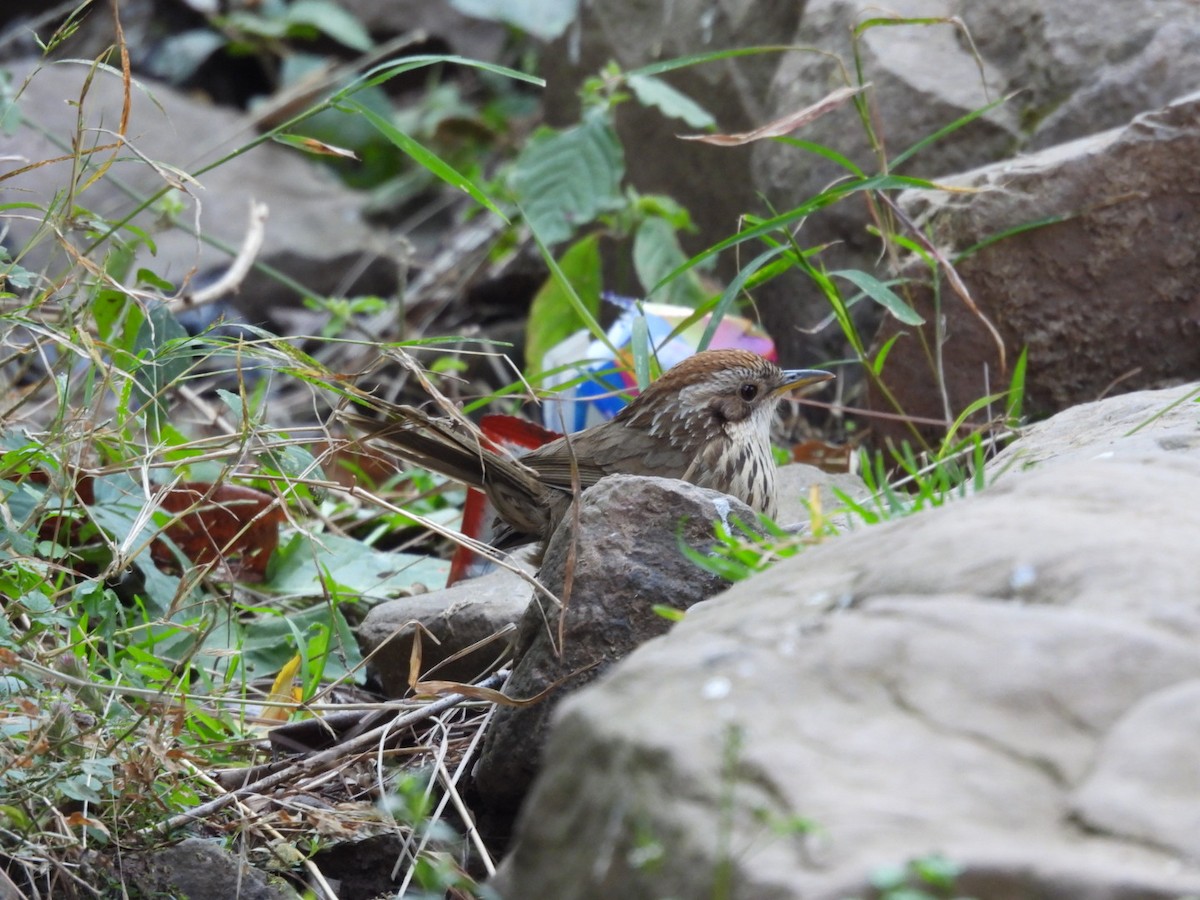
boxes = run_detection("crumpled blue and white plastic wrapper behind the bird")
[542,296,775,432]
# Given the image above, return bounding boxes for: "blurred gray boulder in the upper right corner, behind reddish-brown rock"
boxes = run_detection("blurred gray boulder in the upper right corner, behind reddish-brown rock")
[752,0,1200,362]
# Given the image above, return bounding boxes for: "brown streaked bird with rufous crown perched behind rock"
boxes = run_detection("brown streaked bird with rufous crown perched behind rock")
[338,349,834,548]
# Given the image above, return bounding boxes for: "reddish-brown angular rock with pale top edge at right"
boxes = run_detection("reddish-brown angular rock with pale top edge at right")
[874,94,1200,438]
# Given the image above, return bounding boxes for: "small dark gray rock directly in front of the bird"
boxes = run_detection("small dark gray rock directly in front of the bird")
[474,475,756,818]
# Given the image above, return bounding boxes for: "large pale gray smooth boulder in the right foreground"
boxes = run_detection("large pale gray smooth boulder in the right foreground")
[498,386,1200,900]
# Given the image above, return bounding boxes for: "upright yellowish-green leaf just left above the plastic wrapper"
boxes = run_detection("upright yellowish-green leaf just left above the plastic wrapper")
[526,234,601,373]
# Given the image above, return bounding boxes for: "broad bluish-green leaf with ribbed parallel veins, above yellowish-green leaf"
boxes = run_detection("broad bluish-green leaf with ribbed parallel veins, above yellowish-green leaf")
[512,110,625,246]
